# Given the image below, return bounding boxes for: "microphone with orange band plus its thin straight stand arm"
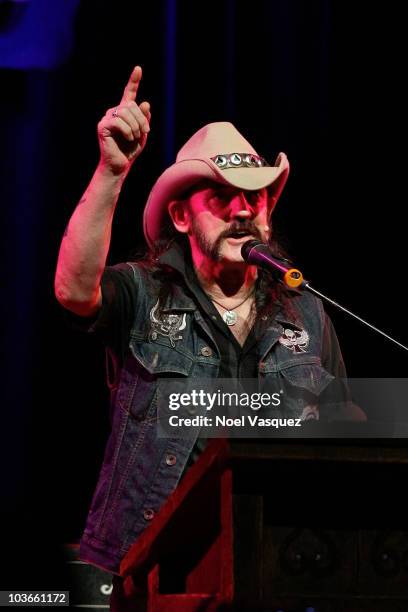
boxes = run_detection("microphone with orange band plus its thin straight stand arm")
[241,240,408,351]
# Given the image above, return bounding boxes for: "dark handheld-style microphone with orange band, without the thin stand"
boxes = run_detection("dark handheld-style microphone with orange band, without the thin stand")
[241,240,307,289]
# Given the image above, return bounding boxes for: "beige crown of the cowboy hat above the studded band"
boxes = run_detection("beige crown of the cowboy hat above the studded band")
[176,121,257,162]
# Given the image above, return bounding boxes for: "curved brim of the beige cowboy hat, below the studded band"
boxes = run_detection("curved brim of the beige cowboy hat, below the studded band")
[143,153,289,247]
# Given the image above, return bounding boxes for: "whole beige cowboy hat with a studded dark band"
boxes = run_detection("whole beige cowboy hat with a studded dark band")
[143,121,289,246]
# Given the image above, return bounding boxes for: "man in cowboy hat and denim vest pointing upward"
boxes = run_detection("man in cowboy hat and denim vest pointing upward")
[55,67,352,584]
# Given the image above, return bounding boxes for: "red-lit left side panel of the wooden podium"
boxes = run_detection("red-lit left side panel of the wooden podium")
[120,440,234,612]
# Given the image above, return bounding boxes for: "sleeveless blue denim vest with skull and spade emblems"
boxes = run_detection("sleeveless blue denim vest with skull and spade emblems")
[80,263,333,573]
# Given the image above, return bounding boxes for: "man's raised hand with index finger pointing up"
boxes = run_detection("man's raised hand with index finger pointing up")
[98,66,151,174]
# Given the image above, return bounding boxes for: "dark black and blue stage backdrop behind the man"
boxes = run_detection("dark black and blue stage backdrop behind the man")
[0,0,408,589]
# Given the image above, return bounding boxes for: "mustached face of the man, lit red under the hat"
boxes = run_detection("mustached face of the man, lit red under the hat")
[186,181,270,263]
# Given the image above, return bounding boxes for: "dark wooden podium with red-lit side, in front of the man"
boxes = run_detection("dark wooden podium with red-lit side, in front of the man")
[120,432,408,612]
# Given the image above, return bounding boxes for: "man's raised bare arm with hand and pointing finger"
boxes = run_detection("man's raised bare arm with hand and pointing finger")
[55,66,151,316]
